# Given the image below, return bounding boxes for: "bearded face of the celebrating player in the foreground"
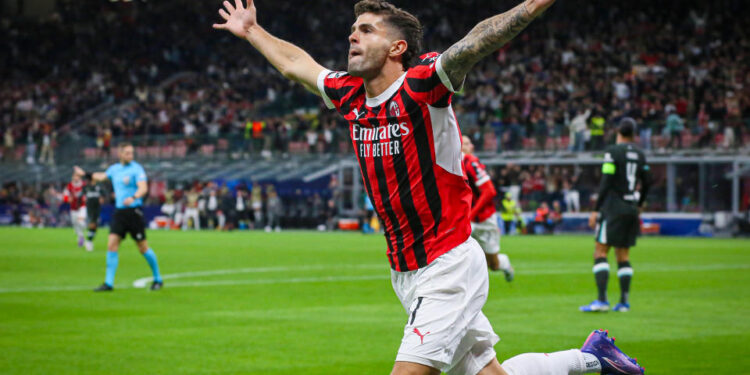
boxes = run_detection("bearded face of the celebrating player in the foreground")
[347,13,393,79]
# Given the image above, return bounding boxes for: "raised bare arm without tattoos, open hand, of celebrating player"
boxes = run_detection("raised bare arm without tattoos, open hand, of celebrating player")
[213,0,324,95]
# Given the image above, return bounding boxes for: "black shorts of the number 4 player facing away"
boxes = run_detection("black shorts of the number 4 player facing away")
[596,205,641,248]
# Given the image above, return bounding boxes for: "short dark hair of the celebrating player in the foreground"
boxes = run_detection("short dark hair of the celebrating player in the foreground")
[354,0,422,69]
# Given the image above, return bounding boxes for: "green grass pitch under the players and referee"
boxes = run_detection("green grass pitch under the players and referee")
[0,228,750,374]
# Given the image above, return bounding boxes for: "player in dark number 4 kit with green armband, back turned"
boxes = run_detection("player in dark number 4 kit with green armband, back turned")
[580,117,651,312]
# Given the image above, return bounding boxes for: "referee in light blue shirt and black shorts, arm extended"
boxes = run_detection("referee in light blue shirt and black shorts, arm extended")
[75,143,164,292]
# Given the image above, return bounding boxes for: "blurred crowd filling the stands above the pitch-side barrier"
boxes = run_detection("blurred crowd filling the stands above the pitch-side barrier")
[0,0,750,163]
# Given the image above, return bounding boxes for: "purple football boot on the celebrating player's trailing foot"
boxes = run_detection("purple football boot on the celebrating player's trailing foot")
[581,330,644,375]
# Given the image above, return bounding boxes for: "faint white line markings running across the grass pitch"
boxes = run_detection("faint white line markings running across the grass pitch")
[0,264,750,294]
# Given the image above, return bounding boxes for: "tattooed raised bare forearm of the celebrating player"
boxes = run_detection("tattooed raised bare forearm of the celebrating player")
[441,0,555,87]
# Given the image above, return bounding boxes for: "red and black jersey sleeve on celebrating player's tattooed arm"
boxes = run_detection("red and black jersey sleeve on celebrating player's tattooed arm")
[406,52,460,108]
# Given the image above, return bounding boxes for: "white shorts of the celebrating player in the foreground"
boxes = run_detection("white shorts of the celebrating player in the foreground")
[391,238,500,375]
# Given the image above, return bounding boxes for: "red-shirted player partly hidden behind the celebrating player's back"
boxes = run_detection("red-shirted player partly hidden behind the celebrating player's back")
[461,136,513,282]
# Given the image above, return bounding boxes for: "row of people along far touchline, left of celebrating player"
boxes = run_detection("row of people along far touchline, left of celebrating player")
[0,177,341,232]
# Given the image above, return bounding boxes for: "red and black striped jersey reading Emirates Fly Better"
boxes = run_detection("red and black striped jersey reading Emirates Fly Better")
[318,53,471,272]
